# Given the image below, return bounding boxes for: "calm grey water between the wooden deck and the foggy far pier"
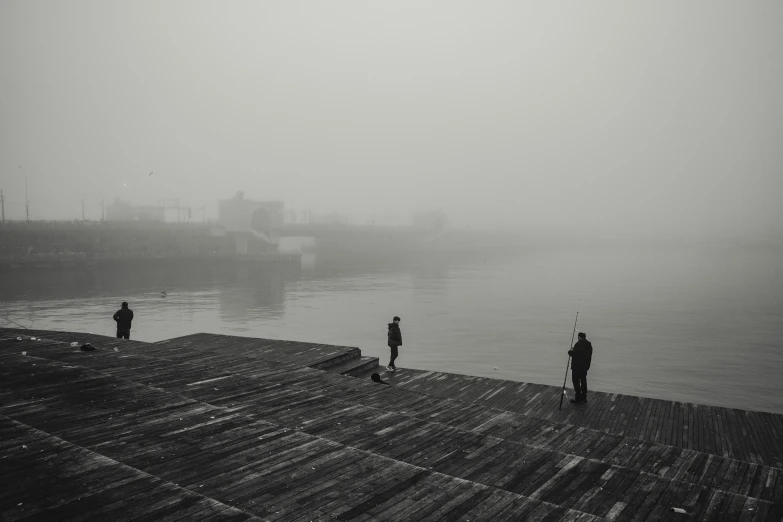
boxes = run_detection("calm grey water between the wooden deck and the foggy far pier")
[0,243,783,413]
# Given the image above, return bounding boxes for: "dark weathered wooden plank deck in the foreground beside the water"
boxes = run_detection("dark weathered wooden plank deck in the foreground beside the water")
[0,329,783,522]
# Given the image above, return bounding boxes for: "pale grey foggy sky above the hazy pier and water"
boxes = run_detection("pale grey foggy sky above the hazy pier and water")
[0,0,783,235]
